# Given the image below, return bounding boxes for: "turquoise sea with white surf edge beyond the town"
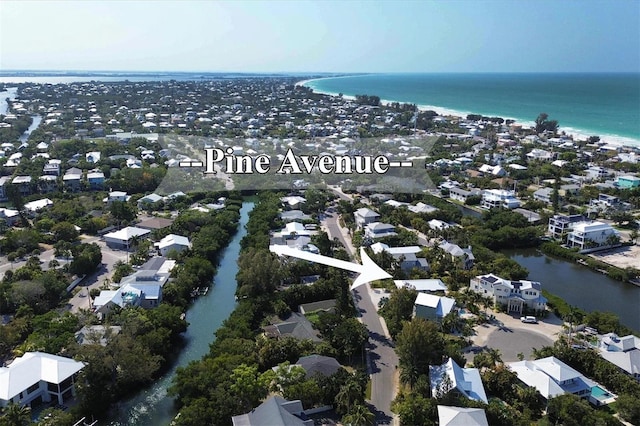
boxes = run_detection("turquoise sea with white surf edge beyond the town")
[304,73,640,145]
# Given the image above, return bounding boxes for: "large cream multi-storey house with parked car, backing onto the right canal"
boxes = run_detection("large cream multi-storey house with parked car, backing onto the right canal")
[469,274,547,313]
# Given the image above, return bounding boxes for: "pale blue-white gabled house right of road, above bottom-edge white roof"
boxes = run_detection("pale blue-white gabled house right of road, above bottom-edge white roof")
[429,358,487,404]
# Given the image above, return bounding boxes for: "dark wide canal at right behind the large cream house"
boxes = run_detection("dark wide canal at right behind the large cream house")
[504,249,640,330]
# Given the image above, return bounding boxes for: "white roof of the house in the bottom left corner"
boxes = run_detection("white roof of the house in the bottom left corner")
[0,352,84,401]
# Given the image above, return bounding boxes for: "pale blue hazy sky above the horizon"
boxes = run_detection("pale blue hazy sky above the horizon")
[0,0,640,73]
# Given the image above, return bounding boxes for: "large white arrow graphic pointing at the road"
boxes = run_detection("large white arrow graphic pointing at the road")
[269,245,391,290]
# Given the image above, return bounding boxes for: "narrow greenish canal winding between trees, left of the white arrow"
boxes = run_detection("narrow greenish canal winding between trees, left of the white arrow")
[106,201,255,426]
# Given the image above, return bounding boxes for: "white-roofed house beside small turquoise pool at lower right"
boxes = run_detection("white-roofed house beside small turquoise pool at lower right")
[507,356,591,399]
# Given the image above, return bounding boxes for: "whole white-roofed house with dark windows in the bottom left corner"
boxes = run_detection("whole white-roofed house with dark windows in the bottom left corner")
[0,352,85,407]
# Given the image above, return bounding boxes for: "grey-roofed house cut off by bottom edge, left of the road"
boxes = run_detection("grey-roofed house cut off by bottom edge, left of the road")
[231,395,314,426]
